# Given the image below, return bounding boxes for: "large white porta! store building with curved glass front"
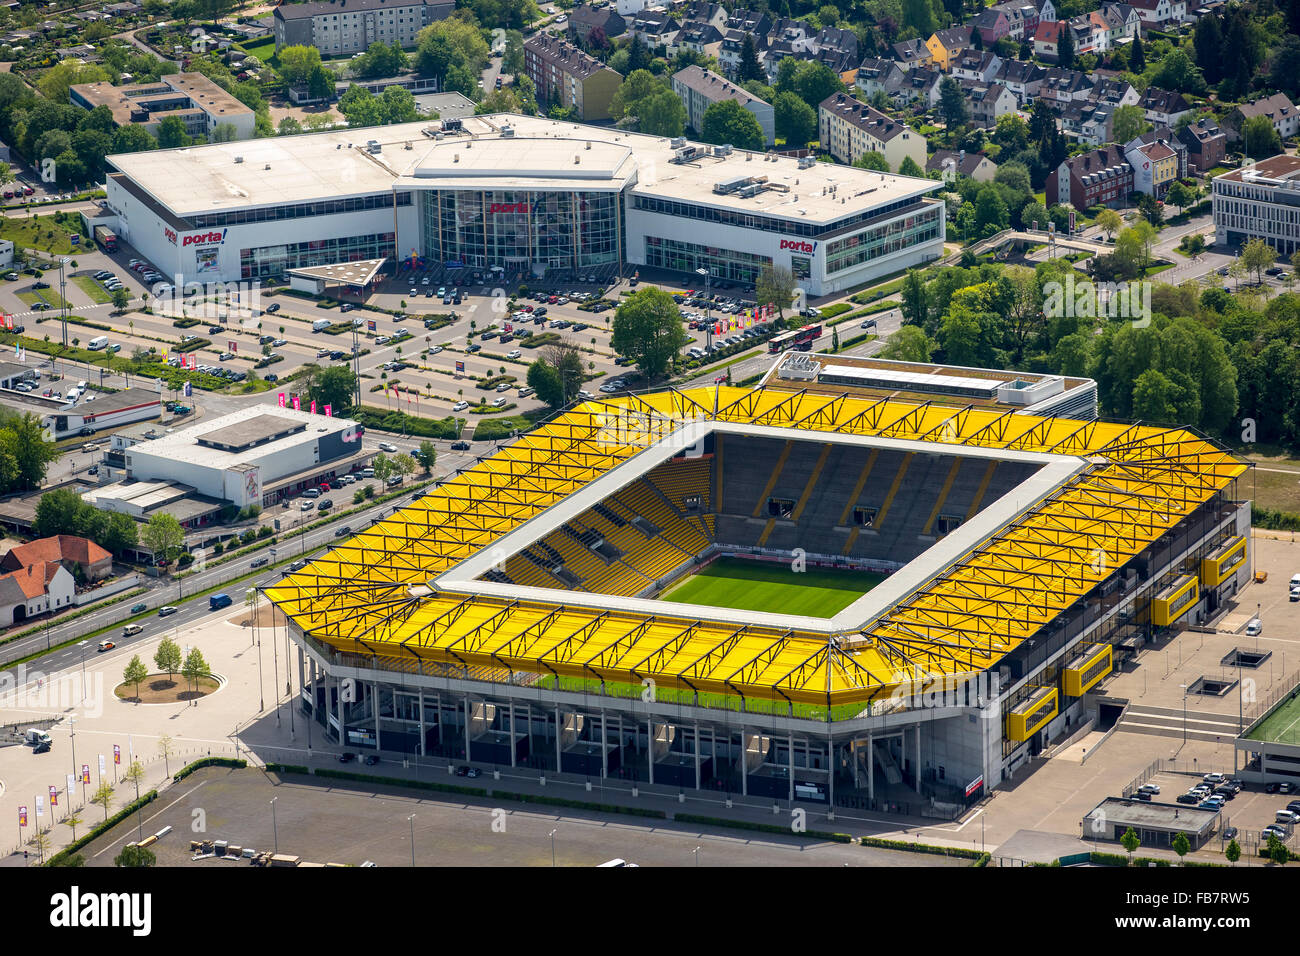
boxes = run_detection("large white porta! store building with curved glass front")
[96,114,944,295]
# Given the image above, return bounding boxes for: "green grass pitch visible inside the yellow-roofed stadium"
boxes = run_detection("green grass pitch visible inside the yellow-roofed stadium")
[659,558,885,618]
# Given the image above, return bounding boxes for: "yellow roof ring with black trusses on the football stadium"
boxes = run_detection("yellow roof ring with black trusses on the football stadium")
[267,386,1247,706]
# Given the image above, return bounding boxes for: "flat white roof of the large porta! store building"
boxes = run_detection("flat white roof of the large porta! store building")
[111,113,943,222]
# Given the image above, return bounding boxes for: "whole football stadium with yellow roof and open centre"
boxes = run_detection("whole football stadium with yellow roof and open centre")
[267,378,1251,813]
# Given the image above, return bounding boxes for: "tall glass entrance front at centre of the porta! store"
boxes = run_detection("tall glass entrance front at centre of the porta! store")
[420,190,623,269]
